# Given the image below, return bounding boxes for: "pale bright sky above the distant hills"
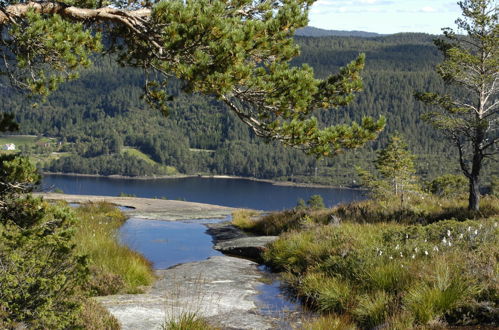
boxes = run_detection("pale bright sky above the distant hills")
[309,0,461,34]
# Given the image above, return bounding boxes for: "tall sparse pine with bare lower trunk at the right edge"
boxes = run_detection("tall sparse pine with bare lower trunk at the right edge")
[417,0,499,211]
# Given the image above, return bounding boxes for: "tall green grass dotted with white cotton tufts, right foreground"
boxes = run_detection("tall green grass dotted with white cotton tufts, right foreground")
[264,218,499,329]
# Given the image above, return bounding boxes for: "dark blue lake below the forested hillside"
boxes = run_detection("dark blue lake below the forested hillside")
[42,175,365,210]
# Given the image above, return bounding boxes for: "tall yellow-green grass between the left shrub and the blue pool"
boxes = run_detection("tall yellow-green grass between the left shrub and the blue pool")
[75,203,154,295]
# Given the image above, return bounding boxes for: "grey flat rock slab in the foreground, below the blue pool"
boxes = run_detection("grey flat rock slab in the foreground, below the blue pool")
[97,256,275,330]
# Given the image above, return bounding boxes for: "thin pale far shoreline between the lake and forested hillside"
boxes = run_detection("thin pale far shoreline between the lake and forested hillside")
[42,172,365,190]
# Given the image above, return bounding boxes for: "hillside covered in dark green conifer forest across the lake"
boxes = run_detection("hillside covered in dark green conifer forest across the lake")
[0,34,499,185]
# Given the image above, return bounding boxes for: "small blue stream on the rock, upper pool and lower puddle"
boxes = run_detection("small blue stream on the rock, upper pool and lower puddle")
[120,218,304,329]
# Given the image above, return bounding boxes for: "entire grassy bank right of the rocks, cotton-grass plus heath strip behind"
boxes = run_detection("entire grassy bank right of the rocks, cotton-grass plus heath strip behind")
[235,197,499,329]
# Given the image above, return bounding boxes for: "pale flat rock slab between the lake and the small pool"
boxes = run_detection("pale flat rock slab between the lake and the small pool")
[37,193,235,221]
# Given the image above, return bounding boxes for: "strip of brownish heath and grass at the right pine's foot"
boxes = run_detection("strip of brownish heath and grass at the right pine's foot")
[233,195,499,235]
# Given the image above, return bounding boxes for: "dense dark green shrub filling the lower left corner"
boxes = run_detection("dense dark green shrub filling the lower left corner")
[0,200,88,329]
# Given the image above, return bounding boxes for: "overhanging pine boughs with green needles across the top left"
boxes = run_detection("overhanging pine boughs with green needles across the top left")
[0,0,385,156]
